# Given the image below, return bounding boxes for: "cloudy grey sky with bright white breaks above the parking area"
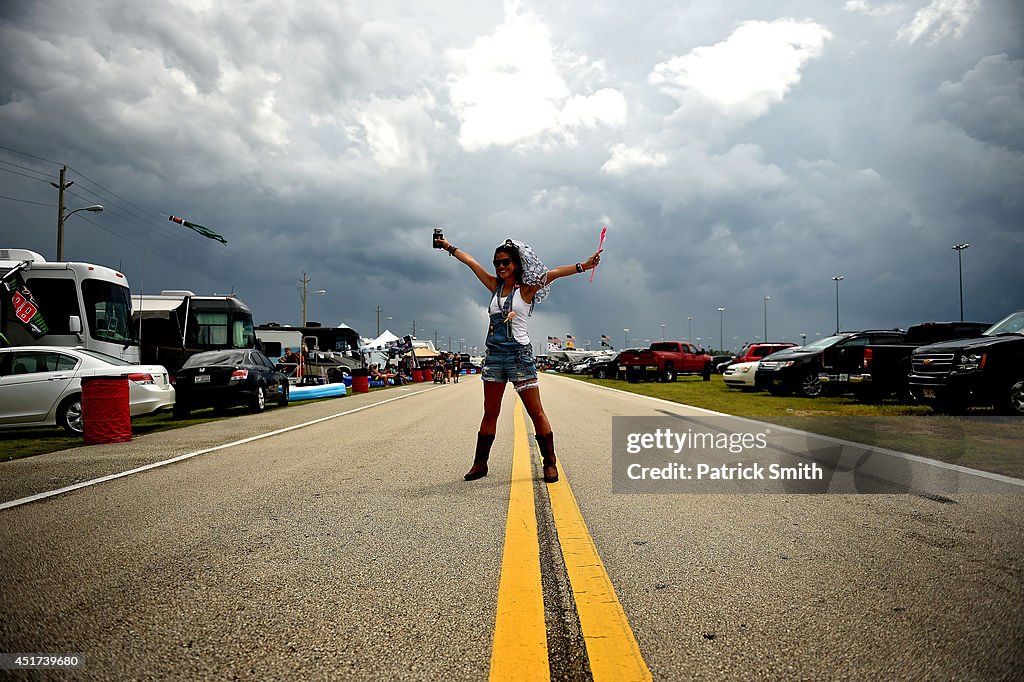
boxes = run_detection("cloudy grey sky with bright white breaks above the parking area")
[0,0,1024,349]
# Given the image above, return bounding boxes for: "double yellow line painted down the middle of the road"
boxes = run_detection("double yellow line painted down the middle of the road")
[490,399,651,682]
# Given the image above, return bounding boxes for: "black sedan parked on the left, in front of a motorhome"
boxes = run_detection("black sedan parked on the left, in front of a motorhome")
[174,348,288,418]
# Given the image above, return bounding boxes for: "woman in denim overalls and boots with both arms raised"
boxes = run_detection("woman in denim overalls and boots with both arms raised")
[435,238,601,483]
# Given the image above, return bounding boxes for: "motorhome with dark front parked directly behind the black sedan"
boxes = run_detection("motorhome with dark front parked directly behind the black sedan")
[131,290,256,372]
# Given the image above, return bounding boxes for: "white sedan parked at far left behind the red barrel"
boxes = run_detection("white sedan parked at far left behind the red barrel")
[0,346,175,435]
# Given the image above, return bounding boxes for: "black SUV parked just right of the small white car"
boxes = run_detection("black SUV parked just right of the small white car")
[754,329,903,397]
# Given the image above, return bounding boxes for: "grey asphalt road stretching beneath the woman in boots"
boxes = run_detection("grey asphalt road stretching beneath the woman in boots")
[0,376,1024,680]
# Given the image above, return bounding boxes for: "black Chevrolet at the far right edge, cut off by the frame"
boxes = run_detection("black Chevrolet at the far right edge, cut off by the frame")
[907,310,1024,416]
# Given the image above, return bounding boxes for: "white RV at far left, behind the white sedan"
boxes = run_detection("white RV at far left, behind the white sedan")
[0,244,139,363]
